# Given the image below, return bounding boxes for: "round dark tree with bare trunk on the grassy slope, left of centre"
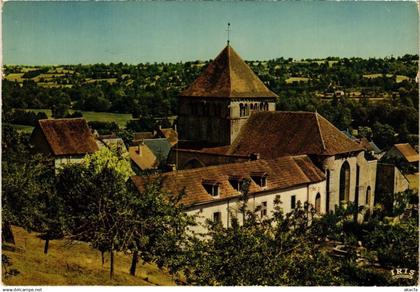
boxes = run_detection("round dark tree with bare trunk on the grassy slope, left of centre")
[57,164,135,278]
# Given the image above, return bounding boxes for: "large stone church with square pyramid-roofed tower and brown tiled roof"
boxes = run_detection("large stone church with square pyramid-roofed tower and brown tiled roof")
[169,45,377,212]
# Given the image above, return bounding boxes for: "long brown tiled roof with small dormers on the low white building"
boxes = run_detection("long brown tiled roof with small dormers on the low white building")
[132,155,325,206]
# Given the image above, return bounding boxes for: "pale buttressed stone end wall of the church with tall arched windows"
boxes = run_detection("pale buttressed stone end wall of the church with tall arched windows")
[324,152,377,211]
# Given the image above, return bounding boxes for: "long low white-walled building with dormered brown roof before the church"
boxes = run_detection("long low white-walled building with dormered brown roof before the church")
[132,155,326,232]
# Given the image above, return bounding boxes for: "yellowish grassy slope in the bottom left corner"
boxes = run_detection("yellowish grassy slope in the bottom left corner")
[2,227,175,286]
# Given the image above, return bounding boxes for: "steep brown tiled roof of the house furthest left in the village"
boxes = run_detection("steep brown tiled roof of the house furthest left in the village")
[34,118,98,155]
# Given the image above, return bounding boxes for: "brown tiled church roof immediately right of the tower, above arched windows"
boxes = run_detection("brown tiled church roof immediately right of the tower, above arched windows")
[227,112,363,159]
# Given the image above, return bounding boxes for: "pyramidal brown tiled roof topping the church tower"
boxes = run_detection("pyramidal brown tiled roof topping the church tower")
[180,45,277,98]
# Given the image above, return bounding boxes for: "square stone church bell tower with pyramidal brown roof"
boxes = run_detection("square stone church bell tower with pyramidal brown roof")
[178,41,278,146]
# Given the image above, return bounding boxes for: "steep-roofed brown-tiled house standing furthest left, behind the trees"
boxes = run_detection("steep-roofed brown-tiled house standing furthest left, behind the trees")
[30,118,99,170]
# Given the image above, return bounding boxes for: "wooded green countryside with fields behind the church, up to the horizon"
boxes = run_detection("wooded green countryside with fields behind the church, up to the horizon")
[2,54,418,151]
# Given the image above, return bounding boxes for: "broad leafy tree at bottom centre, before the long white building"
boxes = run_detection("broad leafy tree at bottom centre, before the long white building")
[184,199,343,285]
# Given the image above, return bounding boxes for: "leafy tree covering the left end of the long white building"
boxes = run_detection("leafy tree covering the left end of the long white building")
[126,179,194,276]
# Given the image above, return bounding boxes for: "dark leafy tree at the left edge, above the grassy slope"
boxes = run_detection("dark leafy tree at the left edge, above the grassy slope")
[2,155,58,250]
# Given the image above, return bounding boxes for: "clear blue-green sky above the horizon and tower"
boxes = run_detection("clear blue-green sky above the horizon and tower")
[2,1,418,65]
